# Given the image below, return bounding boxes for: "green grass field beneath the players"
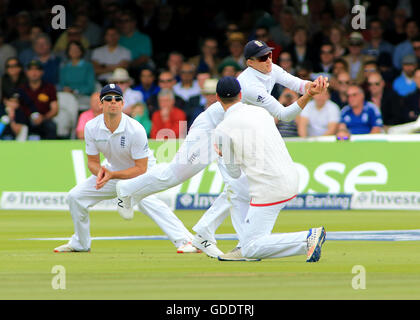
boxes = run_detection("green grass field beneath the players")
[0,211,420,300]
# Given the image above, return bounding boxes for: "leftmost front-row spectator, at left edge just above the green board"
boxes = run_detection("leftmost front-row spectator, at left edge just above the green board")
[0,92,29,140]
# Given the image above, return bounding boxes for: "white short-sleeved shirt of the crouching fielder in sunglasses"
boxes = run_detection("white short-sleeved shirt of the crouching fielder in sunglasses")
[85,113,156,171]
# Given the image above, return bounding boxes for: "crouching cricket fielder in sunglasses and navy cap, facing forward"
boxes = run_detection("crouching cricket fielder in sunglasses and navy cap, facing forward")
[54,84,198,253]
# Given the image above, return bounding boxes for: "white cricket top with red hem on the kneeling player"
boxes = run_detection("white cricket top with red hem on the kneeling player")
[215,102,299,206]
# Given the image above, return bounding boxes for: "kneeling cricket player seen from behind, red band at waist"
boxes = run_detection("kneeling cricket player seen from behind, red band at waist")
[215,77,326,262]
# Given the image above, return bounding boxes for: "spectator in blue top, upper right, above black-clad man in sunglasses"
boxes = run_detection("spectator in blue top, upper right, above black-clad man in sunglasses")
[362,19,394,58]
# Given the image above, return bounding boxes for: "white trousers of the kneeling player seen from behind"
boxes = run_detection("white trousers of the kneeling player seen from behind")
[238,203,308,259]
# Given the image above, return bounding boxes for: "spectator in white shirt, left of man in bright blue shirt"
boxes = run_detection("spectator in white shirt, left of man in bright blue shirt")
[296,91,340,138]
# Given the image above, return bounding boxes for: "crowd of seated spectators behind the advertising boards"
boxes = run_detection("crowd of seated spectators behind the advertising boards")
[0,0,420,140]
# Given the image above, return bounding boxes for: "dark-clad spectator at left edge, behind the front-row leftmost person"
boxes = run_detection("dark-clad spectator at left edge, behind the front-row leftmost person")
[0,57,26,97]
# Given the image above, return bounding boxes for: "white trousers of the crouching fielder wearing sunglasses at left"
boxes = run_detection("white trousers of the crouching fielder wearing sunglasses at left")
[67,176,192,251]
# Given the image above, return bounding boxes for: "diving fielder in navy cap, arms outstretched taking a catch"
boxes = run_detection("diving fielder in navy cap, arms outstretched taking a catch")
[117,41,328,257]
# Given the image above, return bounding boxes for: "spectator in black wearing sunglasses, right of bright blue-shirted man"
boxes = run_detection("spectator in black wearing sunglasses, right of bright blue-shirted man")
[366,72,406,128]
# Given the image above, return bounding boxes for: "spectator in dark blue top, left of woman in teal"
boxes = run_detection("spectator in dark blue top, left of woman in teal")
[21,33,61,85]
